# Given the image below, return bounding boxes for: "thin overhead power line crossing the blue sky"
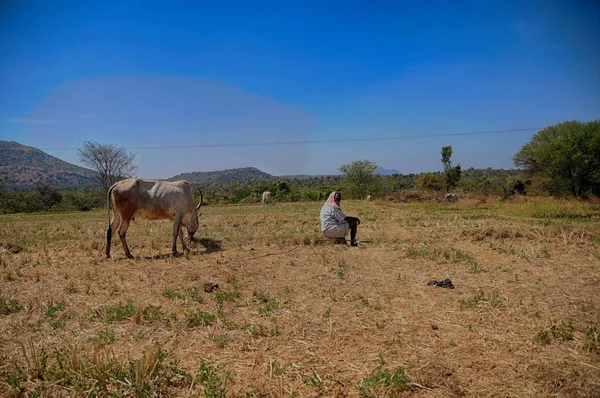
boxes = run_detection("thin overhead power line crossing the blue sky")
[4,127,544,150]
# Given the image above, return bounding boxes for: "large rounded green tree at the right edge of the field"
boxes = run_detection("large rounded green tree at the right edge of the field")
[513,120,600,197]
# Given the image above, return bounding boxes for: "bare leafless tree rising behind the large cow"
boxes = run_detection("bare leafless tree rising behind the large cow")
[78,141,137,192]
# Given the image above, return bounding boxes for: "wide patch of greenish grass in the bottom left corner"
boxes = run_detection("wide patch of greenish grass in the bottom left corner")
[0,343,192,397]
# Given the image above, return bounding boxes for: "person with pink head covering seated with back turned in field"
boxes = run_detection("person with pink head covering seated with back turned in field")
[321,191,360,246]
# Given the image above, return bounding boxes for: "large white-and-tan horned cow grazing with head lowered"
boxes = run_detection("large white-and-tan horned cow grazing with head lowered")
[106,178,203,258]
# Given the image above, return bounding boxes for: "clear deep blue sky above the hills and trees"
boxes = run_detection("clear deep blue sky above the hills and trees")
[0,0,600,178]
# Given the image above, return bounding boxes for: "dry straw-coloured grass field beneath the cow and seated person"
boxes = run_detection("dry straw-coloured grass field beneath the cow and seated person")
[0,198,600,397]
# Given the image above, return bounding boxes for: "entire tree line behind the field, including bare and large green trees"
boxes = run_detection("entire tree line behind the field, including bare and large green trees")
[0,120,600,213]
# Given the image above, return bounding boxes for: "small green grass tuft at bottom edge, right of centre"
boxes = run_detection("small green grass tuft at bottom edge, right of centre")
[358,366,410,398]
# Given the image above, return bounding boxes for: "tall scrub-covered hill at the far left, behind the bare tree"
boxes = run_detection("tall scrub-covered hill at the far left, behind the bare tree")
[0,141,99,189]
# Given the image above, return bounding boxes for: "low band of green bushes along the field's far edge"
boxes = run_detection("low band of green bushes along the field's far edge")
[0,166,522,214]
